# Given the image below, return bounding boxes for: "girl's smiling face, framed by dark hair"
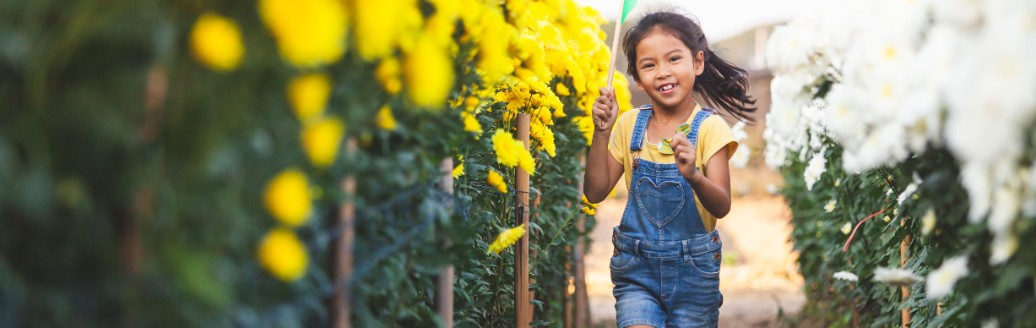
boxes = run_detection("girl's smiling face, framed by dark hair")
[636,27,704,110]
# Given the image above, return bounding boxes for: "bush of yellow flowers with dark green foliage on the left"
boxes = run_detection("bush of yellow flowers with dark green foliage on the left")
[0,0,631,327]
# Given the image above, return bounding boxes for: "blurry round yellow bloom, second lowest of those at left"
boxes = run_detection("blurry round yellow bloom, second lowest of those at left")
[263,168,313,227]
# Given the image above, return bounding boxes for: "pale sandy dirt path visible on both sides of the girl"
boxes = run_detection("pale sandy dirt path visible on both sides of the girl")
[585,190,805,327]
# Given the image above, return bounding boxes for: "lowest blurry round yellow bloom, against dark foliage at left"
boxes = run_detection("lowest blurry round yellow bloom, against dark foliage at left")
[258,228,310,282]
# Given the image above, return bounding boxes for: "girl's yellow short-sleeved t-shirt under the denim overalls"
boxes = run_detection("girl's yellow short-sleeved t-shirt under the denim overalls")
[608,106,738,232]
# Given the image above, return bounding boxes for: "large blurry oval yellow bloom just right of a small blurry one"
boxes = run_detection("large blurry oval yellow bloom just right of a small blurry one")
[403,38,454,110]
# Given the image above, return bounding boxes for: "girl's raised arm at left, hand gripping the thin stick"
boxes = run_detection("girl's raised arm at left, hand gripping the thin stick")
[583,88,623,203]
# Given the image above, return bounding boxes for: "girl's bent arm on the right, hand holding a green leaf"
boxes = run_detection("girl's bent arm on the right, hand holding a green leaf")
[672,133,730,218]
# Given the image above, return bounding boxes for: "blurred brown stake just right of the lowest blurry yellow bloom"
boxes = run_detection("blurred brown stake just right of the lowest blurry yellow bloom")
[332,138,356,328]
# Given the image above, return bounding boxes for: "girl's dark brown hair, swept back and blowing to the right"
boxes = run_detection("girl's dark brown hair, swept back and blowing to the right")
[623,10,756,122]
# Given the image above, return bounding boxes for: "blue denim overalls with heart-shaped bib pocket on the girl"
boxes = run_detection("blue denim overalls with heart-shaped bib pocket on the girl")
[610,107,723,327]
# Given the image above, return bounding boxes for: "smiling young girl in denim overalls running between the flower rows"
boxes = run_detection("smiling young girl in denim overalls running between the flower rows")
[583,9,755,327]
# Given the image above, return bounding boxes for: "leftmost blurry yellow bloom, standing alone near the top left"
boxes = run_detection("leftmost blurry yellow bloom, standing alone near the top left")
[191,12,244,71]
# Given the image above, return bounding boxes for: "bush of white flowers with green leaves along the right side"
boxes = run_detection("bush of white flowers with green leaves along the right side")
[765,0,1036,326]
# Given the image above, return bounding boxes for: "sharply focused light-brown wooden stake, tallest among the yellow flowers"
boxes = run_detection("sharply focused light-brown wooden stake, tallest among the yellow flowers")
[515,113,531,328]
